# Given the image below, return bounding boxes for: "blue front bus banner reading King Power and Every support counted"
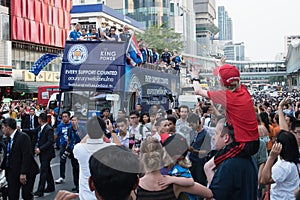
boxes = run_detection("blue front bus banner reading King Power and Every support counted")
[60,41,126,91]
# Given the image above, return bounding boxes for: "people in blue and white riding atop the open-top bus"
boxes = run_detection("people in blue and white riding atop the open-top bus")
[68,22,182,71]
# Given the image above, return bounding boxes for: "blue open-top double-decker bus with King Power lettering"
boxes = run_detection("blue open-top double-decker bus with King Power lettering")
[58,41,180,120]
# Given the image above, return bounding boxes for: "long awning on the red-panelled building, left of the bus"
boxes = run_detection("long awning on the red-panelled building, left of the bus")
[13,81,59,93]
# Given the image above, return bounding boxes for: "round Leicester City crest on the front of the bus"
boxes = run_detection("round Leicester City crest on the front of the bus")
[68,44,88,65]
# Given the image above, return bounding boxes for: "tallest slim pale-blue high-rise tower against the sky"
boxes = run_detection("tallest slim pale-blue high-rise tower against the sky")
[218,6,232,40]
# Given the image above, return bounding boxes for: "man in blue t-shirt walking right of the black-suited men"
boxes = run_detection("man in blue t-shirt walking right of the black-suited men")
[54,111,72,184]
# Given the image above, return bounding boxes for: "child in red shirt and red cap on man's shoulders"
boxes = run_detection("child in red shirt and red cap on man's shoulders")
[193,64,259,184]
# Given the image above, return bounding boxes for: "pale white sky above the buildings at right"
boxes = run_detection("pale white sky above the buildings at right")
[215,0,300,61]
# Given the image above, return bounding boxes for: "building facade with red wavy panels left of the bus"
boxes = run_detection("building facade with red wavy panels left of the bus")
[0,0,72,99]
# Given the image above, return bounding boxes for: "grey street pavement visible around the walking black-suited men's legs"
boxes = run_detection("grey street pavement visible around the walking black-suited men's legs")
[33,150,78,200]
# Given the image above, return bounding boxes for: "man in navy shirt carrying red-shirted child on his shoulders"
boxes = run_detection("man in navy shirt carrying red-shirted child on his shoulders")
[209,118,258,200]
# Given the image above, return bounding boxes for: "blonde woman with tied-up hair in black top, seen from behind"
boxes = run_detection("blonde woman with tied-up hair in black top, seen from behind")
[136,137,213,200]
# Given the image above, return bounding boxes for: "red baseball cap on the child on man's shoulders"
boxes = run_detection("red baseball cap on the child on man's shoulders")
[214,64,240,86]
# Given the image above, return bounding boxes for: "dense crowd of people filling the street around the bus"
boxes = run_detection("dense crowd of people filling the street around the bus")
[0,61,300,200]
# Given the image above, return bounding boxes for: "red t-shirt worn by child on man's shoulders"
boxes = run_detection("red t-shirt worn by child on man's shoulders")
[207,85,259,142]
